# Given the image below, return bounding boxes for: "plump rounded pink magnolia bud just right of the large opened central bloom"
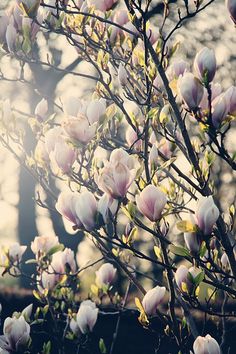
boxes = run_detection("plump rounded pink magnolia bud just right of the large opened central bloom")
[136,184,167,222]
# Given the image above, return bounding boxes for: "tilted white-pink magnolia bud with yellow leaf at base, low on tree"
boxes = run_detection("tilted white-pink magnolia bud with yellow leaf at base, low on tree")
[142,286,166,316]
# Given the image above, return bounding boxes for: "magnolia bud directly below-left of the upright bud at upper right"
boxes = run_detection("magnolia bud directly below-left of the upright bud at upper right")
[177,72,203,110]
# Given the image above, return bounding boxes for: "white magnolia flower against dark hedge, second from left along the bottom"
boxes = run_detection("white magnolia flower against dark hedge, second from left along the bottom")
[70,300,98,335]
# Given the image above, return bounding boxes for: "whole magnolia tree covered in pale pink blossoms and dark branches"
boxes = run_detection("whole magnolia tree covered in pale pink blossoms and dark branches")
[0,0,236,354]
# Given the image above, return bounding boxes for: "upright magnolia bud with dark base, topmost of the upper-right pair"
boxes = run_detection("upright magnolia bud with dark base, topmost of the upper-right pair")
[194,47,216,83]
